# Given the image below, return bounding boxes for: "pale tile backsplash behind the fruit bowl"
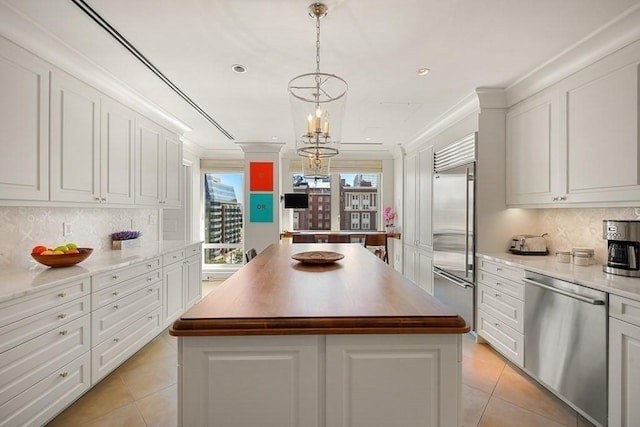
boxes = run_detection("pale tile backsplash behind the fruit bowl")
[0,207,159,268]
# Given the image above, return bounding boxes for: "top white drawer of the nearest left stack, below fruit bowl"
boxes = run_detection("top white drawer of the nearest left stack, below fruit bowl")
[0,277,91,327]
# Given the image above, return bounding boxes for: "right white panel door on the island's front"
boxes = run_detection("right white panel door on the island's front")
[326,335,462,427]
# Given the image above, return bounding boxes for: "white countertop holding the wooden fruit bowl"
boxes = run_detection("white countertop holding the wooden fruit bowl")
[0,240,202,302]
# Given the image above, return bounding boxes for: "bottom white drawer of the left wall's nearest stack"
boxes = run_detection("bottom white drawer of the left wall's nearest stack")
[0,352,91,427]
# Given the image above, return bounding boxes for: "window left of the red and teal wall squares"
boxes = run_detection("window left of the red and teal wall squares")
[204,173,244,265]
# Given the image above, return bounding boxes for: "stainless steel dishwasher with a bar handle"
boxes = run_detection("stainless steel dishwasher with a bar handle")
[523,271,607,426]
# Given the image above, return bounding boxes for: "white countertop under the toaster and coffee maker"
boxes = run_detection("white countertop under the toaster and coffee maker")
[477,253,640,301]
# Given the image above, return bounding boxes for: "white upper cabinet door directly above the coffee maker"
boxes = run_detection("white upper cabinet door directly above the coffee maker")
[564,63,640,202]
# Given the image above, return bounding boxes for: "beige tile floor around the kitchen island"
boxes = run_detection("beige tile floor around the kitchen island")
[48,282,591,427]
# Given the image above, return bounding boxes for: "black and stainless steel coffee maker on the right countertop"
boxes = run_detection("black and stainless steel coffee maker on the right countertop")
[602,220,640,277]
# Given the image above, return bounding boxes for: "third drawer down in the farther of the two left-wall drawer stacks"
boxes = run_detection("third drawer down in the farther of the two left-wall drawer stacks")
[91,281,161,346]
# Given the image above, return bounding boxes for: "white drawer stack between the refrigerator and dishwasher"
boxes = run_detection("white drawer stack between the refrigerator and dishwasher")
[476,258,524,367]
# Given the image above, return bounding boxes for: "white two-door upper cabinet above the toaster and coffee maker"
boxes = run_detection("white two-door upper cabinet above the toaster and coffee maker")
[506,43,640,206]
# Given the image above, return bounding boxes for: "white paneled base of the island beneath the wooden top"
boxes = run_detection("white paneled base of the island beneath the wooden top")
[178,334,462,427]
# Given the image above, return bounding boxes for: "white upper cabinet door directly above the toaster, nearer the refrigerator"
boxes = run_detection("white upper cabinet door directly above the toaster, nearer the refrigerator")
[506,94,561,204]
